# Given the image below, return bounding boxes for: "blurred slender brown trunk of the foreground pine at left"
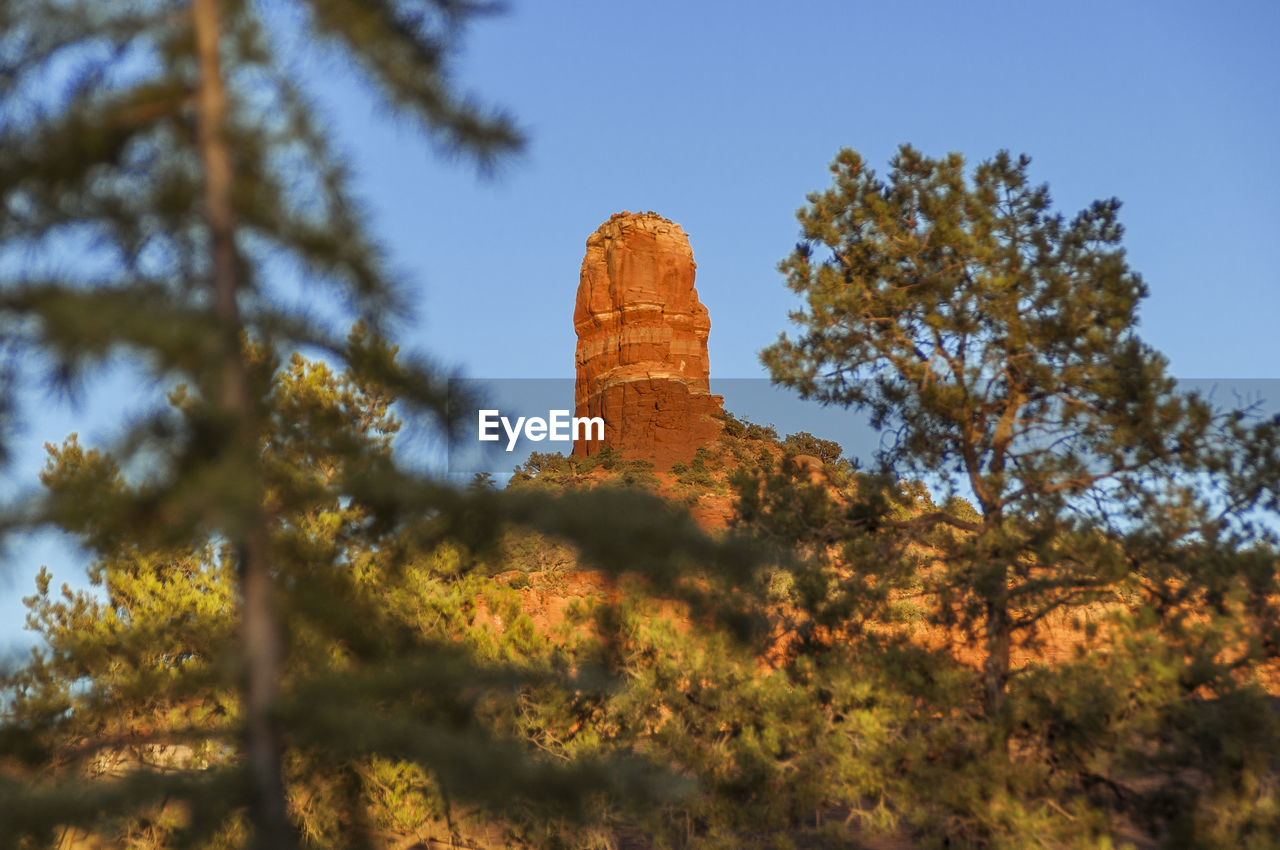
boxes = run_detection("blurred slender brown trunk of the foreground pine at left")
[192,0,296,850]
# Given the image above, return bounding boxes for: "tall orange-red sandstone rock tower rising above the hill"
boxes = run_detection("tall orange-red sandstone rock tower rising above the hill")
[573,213,723,469]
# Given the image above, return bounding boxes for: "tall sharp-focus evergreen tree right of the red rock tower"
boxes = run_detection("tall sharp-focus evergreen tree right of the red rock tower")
[763,146,1277,718]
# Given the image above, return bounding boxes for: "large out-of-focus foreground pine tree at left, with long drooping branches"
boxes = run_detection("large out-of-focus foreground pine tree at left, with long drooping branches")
[0,0,752,847]
